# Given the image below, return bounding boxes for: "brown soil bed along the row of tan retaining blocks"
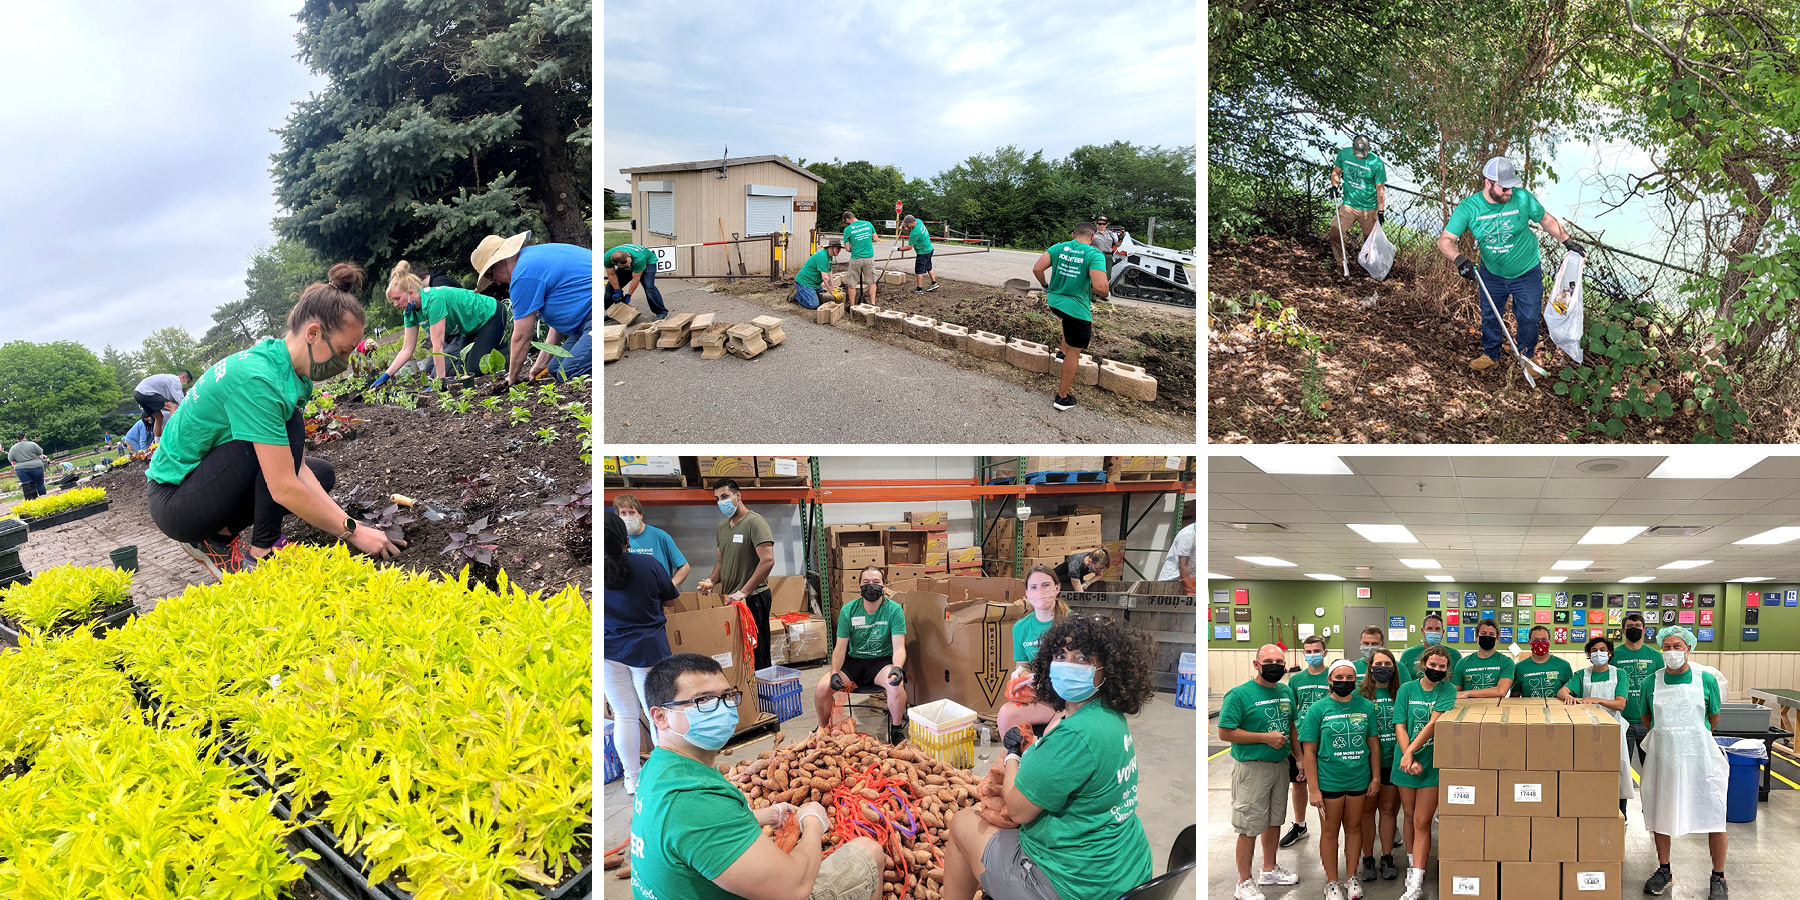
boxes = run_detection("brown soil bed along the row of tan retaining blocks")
[702,277,1197,430]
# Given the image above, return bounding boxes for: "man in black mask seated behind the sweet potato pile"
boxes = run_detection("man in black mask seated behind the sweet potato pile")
[812,565,905,743]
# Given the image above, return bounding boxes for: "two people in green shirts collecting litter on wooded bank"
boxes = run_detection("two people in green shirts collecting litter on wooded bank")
[1327,135,1588,371]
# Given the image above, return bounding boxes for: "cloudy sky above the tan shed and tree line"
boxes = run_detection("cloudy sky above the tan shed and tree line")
[601,0,1199,189]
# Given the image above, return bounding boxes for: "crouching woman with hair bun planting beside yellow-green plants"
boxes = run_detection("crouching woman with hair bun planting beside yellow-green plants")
[146,263,405,578]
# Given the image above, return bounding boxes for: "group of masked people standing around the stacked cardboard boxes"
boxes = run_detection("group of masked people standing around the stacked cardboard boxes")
[1219,612,1728,900]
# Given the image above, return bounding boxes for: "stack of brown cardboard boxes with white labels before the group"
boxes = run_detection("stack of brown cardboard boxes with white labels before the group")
[1433,698,1625,900]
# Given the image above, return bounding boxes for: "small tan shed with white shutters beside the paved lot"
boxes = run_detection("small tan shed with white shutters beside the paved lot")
[619,157,824,277]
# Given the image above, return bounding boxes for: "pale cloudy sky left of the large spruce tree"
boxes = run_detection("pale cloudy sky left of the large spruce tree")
[0,0,324,355]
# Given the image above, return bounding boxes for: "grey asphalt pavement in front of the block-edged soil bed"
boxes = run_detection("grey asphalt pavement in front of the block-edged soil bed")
[601,282,1197,445]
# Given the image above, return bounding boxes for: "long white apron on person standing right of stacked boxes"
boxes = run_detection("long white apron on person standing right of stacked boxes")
[1643,670,1732,837]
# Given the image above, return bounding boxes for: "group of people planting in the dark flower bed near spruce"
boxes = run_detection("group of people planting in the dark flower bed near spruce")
[135,232,594,578]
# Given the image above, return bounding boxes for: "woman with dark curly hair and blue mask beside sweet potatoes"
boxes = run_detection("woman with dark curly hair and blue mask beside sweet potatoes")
[943,616,1156,900]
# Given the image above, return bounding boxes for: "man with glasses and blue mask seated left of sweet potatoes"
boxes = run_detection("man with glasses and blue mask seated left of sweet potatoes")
[630,653,887,900]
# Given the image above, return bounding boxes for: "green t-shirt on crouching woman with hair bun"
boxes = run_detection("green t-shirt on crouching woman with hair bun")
[146,338,313,484]
